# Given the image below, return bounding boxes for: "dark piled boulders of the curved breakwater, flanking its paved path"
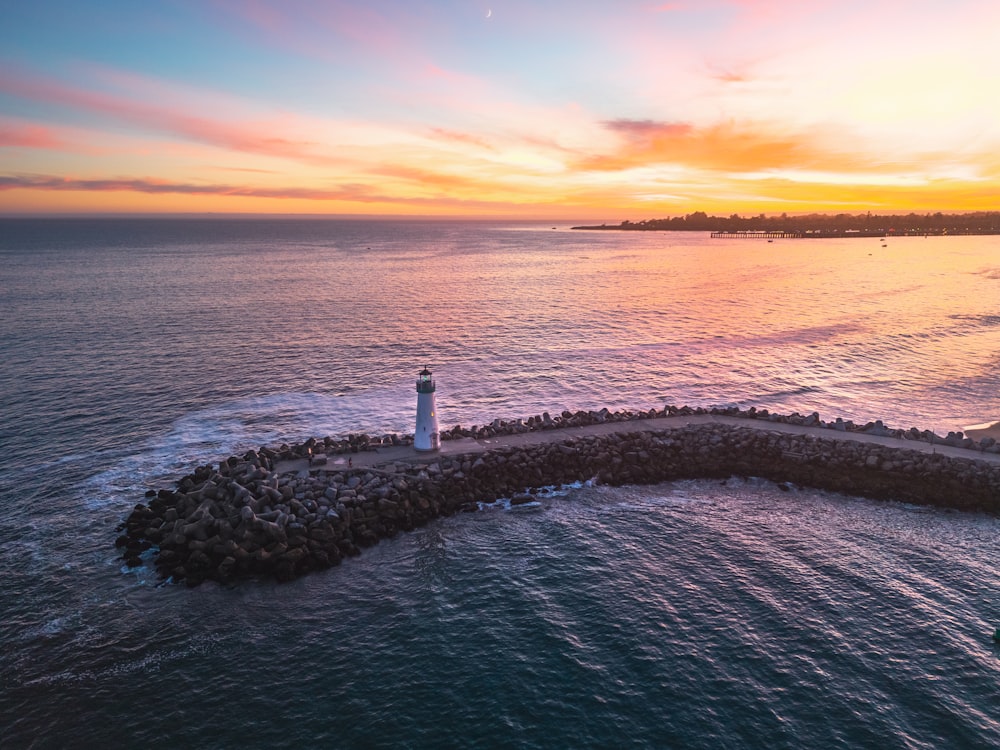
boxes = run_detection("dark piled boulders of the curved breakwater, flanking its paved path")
[116,407,1000,586]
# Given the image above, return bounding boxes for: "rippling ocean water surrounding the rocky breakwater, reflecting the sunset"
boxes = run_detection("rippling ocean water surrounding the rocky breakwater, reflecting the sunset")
[0,218,1000,750]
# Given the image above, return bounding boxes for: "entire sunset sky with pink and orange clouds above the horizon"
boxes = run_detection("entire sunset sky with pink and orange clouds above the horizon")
[0,0,1000,222]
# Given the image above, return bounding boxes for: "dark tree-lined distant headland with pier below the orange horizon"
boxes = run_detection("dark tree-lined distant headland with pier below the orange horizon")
[573,211,1000,238]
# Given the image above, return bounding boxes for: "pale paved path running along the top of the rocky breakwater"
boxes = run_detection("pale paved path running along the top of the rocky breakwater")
[275,414,1000,474]
